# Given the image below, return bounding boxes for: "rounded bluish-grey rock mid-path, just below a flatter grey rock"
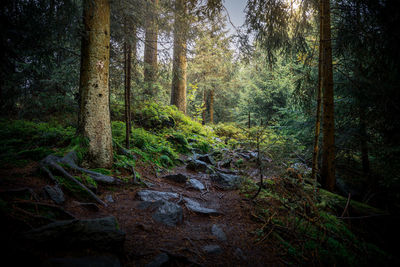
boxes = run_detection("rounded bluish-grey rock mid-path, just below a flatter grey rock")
[152,201,183,226]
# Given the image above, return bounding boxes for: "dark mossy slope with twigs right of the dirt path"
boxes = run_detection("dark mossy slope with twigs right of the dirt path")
[241,177,391,266]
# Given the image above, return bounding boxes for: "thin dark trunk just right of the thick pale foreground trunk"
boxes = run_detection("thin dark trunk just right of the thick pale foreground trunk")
[124,41,132,149]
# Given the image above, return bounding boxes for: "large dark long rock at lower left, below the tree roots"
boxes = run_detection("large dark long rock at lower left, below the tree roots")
[23,216,125,251]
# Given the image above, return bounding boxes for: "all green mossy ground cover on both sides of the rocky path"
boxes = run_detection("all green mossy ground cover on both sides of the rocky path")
[0,103,390,266]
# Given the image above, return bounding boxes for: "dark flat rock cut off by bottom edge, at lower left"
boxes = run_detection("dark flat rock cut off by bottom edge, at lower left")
[41,255,121,267]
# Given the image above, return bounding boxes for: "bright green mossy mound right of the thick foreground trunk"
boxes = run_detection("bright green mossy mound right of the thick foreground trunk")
[112,102,224,168]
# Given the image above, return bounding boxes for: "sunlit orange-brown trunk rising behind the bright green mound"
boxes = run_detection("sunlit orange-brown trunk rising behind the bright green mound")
[171,0,188,114]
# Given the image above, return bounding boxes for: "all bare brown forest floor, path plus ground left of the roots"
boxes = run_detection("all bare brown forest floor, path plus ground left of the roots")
[0,153,285,266]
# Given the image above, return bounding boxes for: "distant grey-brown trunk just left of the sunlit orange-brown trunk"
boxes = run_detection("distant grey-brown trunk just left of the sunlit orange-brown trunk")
[144,0,159,97]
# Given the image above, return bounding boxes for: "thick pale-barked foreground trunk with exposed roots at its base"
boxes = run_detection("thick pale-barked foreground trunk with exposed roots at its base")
[79,0,113,168]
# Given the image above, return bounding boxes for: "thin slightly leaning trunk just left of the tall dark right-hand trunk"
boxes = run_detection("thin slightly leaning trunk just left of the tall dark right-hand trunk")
[311,7,323,182]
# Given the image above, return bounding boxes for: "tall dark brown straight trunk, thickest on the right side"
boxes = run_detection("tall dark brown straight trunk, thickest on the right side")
[320,0,336,191]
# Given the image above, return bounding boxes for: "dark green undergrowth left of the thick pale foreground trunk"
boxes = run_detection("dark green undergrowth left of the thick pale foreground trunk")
[0,120,75,164]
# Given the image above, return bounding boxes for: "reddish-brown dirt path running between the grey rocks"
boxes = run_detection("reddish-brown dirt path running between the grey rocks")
[61,161,280,266]
